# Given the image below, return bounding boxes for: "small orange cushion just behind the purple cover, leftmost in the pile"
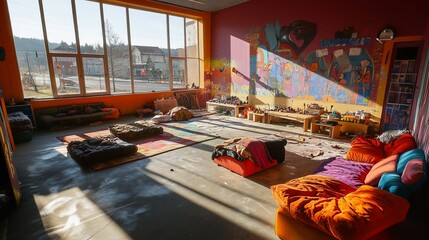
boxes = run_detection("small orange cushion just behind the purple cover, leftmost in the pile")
[346,137,384,164]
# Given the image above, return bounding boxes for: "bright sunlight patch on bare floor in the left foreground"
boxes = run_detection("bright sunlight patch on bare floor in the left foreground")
[34,187,132,240]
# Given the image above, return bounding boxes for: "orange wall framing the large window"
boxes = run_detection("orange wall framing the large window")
[0,0,211,114]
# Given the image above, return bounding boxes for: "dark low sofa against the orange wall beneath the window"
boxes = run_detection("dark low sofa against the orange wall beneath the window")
[35,102,120,128]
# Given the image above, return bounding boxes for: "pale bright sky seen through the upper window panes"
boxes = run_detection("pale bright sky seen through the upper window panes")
[7,0,189,48]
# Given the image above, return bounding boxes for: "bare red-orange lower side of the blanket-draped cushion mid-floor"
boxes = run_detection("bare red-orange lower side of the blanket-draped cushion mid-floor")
[213,156,278,177]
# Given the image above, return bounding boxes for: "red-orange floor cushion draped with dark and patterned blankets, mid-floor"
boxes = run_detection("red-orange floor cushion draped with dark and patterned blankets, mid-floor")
[212,136,287,177]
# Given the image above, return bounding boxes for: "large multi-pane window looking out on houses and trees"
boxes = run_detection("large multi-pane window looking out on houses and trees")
[8,0,202,98]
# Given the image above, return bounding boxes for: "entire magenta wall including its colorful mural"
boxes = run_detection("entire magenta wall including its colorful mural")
[211,0,429,129]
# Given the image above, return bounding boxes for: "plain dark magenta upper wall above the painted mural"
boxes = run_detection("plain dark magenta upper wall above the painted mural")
[211,0,429,59]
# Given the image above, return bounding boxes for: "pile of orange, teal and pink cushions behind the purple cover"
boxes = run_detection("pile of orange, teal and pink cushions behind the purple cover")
[346,131,427,198]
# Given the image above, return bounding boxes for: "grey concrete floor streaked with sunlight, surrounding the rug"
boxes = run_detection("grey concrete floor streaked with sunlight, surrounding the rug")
[2,113,424,240]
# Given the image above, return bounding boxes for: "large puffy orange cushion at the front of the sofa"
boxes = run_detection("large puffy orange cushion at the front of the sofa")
[271,175,409,240]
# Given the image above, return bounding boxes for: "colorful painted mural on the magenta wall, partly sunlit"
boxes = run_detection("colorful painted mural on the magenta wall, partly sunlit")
[212,21,379,106]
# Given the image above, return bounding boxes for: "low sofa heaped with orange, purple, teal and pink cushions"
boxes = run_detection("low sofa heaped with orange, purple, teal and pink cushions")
[271,133,427,240]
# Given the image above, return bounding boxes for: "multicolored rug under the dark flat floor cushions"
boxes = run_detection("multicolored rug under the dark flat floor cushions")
[57,122,219,170]
